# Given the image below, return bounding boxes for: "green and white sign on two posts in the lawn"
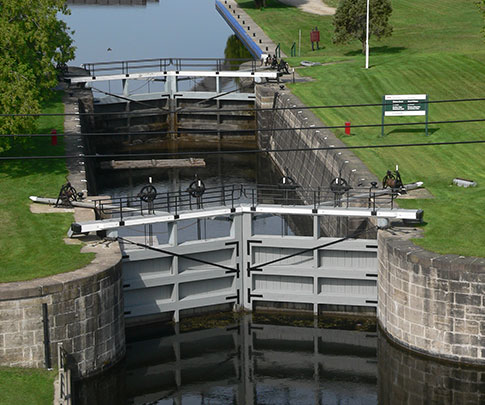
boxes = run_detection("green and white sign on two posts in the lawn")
[381,94,428,136]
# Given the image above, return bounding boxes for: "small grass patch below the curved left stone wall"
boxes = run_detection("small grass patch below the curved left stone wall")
[0,367,56,405]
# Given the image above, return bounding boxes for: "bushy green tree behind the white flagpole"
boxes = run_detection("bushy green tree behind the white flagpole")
[333,0,392,53]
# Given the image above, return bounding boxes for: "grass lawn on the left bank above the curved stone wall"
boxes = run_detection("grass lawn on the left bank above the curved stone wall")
[0,93,94,282]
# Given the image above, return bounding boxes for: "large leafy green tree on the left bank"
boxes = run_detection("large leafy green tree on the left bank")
[0,0,74,151]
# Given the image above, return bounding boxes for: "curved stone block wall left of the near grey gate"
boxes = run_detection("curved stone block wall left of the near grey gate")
[0,244,125,378]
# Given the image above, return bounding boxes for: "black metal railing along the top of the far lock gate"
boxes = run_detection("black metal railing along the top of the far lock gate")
[82,58,261,77]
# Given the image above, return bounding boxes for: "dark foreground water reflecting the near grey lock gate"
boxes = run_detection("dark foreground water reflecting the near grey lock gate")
[76,314,485,405]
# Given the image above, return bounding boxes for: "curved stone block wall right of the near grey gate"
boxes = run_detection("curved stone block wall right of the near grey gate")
[377,229,485,365]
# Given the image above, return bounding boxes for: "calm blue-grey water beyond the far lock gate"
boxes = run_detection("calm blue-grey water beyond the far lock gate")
[64,0,232,66]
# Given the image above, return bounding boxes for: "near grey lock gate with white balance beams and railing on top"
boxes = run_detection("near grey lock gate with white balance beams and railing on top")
[71,182,423,322]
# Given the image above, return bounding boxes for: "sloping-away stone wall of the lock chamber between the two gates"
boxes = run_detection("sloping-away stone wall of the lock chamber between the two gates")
[255,84,379,237]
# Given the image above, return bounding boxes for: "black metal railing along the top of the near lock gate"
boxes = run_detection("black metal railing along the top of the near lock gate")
[95,184,398,219]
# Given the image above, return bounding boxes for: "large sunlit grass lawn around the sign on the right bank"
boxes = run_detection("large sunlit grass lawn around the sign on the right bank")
[239,0,485,256]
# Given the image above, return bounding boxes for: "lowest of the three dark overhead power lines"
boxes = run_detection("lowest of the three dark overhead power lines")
[0,140,485,161]
